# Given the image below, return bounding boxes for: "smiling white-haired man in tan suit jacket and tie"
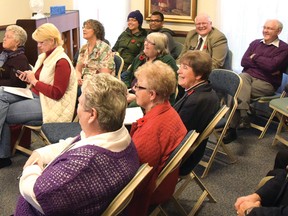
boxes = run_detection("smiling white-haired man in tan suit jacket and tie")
[178,14,228,69]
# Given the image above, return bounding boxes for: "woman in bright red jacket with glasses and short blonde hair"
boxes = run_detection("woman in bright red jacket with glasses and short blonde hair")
[129,61,187,215]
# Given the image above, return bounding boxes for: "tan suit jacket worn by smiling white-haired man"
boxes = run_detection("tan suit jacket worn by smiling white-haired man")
[178,28,228,69]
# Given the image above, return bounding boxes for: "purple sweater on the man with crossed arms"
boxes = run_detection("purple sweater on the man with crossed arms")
[241,39,288,90]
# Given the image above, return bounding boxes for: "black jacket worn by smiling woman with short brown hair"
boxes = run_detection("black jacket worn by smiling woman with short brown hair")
[174,83,219,175]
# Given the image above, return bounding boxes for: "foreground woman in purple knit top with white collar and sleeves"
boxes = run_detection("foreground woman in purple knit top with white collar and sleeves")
[14,73,139,216]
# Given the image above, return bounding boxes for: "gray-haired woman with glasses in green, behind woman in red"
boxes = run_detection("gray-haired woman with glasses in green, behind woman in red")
[125,32,178,106]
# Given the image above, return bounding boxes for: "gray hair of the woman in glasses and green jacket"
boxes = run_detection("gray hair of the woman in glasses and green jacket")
[147,32,169,55]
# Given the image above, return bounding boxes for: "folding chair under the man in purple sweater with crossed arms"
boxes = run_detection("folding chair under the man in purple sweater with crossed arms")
[250,73,288,139]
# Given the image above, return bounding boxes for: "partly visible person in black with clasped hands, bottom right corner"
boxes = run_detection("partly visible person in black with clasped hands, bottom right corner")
[234,153,288,216]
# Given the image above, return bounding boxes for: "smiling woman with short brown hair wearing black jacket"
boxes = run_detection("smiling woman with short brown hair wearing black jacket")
[174,50,219,175]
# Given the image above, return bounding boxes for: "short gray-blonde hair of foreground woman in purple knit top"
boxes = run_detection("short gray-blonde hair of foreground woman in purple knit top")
[82,73,127,132]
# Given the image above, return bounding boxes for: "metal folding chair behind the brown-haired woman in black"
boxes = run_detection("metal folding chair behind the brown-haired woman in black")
[199,69,242,178]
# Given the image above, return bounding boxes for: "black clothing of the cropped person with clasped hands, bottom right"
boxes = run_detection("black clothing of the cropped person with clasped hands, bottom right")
[248,169,288,216]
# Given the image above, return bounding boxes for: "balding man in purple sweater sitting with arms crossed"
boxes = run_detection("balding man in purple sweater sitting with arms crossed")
[223,20,288,143]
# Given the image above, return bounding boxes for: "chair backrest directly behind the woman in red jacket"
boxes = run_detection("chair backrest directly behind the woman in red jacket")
[155,130,199,188]
